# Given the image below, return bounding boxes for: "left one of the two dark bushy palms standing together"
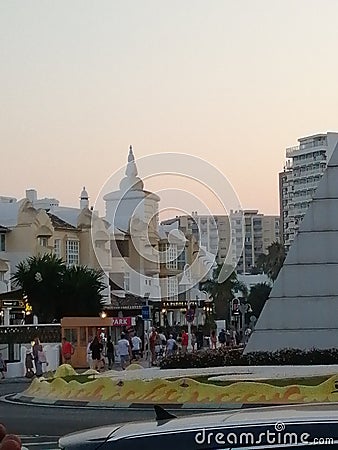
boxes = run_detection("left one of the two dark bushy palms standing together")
[12,254,66,323]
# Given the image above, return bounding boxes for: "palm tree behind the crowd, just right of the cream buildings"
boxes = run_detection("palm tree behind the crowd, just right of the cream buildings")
[201,265,243,320]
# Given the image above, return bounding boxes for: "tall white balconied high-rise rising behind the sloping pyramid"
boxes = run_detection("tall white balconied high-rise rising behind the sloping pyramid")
[279,132,338,250]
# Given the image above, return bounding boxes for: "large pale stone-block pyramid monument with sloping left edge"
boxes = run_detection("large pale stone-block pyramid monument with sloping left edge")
[245,145,338,353]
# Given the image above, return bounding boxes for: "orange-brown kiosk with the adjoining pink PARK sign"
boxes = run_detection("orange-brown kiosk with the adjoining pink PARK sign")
[61,317,136,368]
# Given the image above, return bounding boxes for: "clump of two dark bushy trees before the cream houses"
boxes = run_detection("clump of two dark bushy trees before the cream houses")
[12,254,105,323]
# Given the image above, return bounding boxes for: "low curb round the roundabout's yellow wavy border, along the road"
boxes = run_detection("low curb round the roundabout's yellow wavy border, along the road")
[2,394,248,411]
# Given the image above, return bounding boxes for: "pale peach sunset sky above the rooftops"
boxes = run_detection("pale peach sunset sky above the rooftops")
[0,0,338,214]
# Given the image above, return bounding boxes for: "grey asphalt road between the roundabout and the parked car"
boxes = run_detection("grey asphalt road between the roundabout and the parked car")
[0,382,224,450]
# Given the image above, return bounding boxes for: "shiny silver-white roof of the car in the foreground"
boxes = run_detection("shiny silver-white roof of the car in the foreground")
[111,403,338,440]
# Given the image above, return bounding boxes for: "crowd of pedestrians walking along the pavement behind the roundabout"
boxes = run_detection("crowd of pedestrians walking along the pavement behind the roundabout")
[16,326,251,379]
